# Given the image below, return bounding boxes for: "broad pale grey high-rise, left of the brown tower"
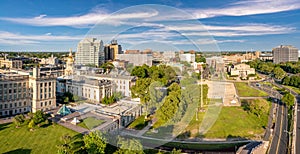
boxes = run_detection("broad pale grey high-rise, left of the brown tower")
[75,38,105,66]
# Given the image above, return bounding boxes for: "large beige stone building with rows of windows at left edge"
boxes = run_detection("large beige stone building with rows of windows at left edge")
[0,68,56,116]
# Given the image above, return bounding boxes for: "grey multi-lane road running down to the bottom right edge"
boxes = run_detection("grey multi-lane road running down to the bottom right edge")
[269,103,288,154]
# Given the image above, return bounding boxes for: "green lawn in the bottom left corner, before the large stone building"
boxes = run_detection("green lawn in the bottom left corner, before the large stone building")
[0,124,78,154]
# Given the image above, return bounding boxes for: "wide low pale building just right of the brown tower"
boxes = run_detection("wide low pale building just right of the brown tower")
[117,54,153,66]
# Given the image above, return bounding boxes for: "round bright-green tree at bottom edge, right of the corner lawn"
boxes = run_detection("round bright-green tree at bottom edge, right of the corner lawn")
[83,131,107,154]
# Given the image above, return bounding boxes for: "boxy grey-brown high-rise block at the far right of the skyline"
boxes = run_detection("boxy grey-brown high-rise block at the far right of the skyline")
[272,45,298,64]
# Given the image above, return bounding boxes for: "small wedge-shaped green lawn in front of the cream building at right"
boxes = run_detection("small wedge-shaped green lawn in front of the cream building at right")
[234,82,268,97]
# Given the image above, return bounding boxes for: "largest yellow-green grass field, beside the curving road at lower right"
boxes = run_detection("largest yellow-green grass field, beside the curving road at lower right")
[182,99,270,138]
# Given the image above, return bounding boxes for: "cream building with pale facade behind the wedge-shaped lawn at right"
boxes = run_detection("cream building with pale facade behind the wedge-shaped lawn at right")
[228,63,255,79]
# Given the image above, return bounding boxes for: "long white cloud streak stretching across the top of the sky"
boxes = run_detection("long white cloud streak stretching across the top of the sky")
[0,0,300,27]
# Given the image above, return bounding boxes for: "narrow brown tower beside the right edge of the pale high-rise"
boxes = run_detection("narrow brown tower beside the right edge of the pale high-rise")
[104,40,122,61]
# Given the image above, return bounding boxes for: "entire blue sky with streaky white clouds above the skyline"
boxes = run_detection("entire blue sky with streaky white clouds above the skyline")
[0,0,300,52]
